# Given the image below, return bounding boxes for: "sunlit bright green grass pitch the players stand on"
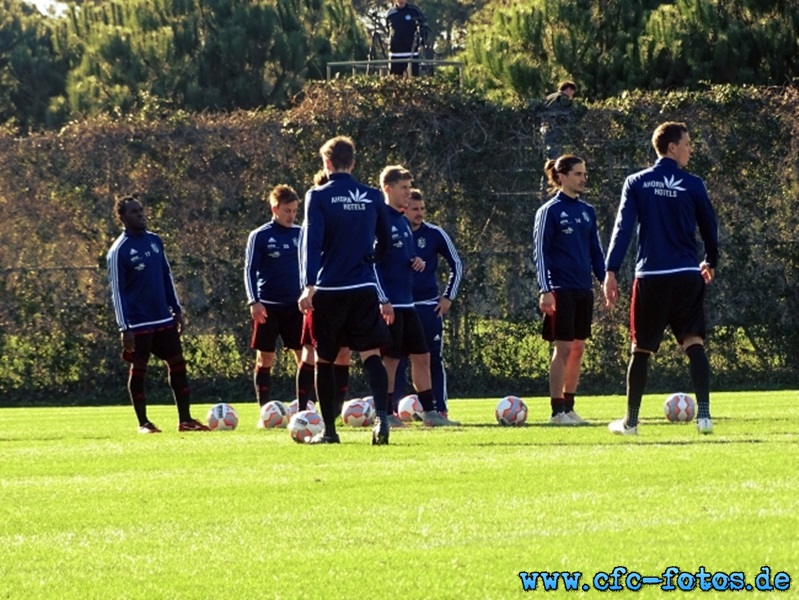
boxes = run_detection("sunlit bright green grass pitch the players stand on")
[0,391,799,599]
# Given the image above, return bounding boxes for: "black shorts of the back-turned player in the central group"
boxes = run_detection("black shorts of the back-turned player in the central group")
[311,286,391,362]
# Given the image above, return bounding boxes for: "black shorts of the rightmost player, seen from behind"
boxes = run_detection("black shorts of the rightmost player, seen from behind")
[630,271,706,352]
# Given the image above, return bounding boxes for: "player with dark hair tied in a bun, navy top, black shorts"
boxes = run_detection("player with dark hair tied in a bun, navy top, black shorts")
[533,154,605,425]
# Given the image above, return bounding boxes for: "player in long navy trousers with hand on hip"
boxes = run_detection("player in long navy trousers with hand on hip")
[402,188,463,417]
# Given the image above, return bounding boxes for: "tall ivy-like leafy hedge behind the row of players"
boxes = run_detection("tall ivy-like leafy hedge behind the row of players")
[0,79,799,402]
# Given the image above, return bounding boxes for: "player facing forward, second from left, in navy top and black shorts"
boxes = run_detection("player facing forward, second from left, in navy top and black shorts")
[244,185,302,428]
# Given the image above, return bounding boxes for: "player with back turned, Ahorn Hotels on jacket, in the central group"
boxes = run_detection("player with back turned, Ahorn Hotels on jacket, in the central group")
[298,136,393,445]
